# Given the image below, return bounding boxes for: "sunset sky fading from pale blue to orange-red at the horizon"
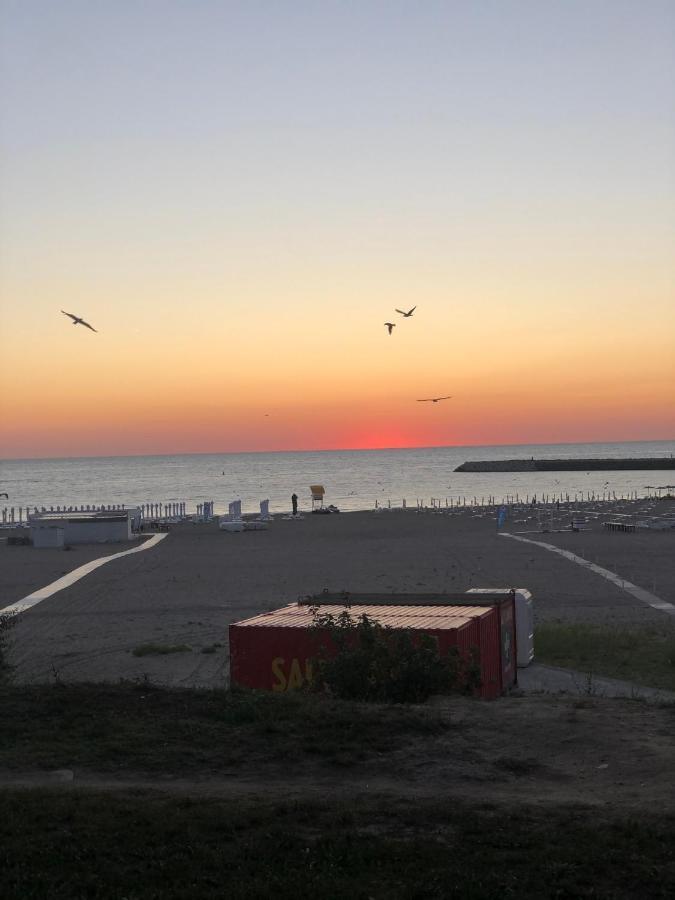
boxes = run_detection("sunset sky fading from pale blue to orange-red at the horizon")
[0,0,675,457]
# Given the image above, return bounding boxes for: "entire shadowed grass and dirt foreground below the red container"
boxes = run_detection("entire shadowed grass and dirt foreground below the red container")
[0,684,675,900]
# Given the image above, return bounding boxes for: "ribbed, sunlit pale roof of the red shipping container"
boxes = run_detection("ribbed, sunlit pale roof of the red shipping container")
[234,603,491,631]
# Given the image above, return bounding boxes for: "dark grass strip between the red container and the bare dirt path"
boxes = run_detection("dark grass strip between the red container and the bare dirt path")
[0,683,452,776]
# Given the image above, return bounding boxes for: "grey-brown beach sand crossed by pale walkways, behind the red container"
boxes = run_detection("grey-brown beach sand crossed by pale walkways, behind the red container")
[0,501,675,686]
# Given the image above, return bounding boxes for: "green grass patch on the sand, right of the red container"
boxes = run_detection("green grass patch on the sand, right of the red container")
[534,622,675,691]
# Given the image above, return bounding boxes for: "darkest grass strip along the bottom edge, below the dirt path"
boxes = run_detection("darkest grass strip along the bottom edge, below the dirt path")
[0,790,675,900]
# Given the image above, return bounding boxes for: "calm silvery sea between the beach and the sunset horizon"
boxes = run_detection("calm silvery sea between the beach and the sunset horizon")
[0,441,675,512]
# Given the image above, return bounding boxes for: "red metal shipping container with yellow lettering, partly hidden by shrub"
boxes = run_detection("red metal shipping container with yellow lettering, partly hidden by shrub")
[230,595,516,698]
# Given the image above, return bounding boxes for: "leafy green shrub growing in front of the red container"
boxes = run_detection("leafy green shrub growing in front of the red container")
[312,607,480,703]
